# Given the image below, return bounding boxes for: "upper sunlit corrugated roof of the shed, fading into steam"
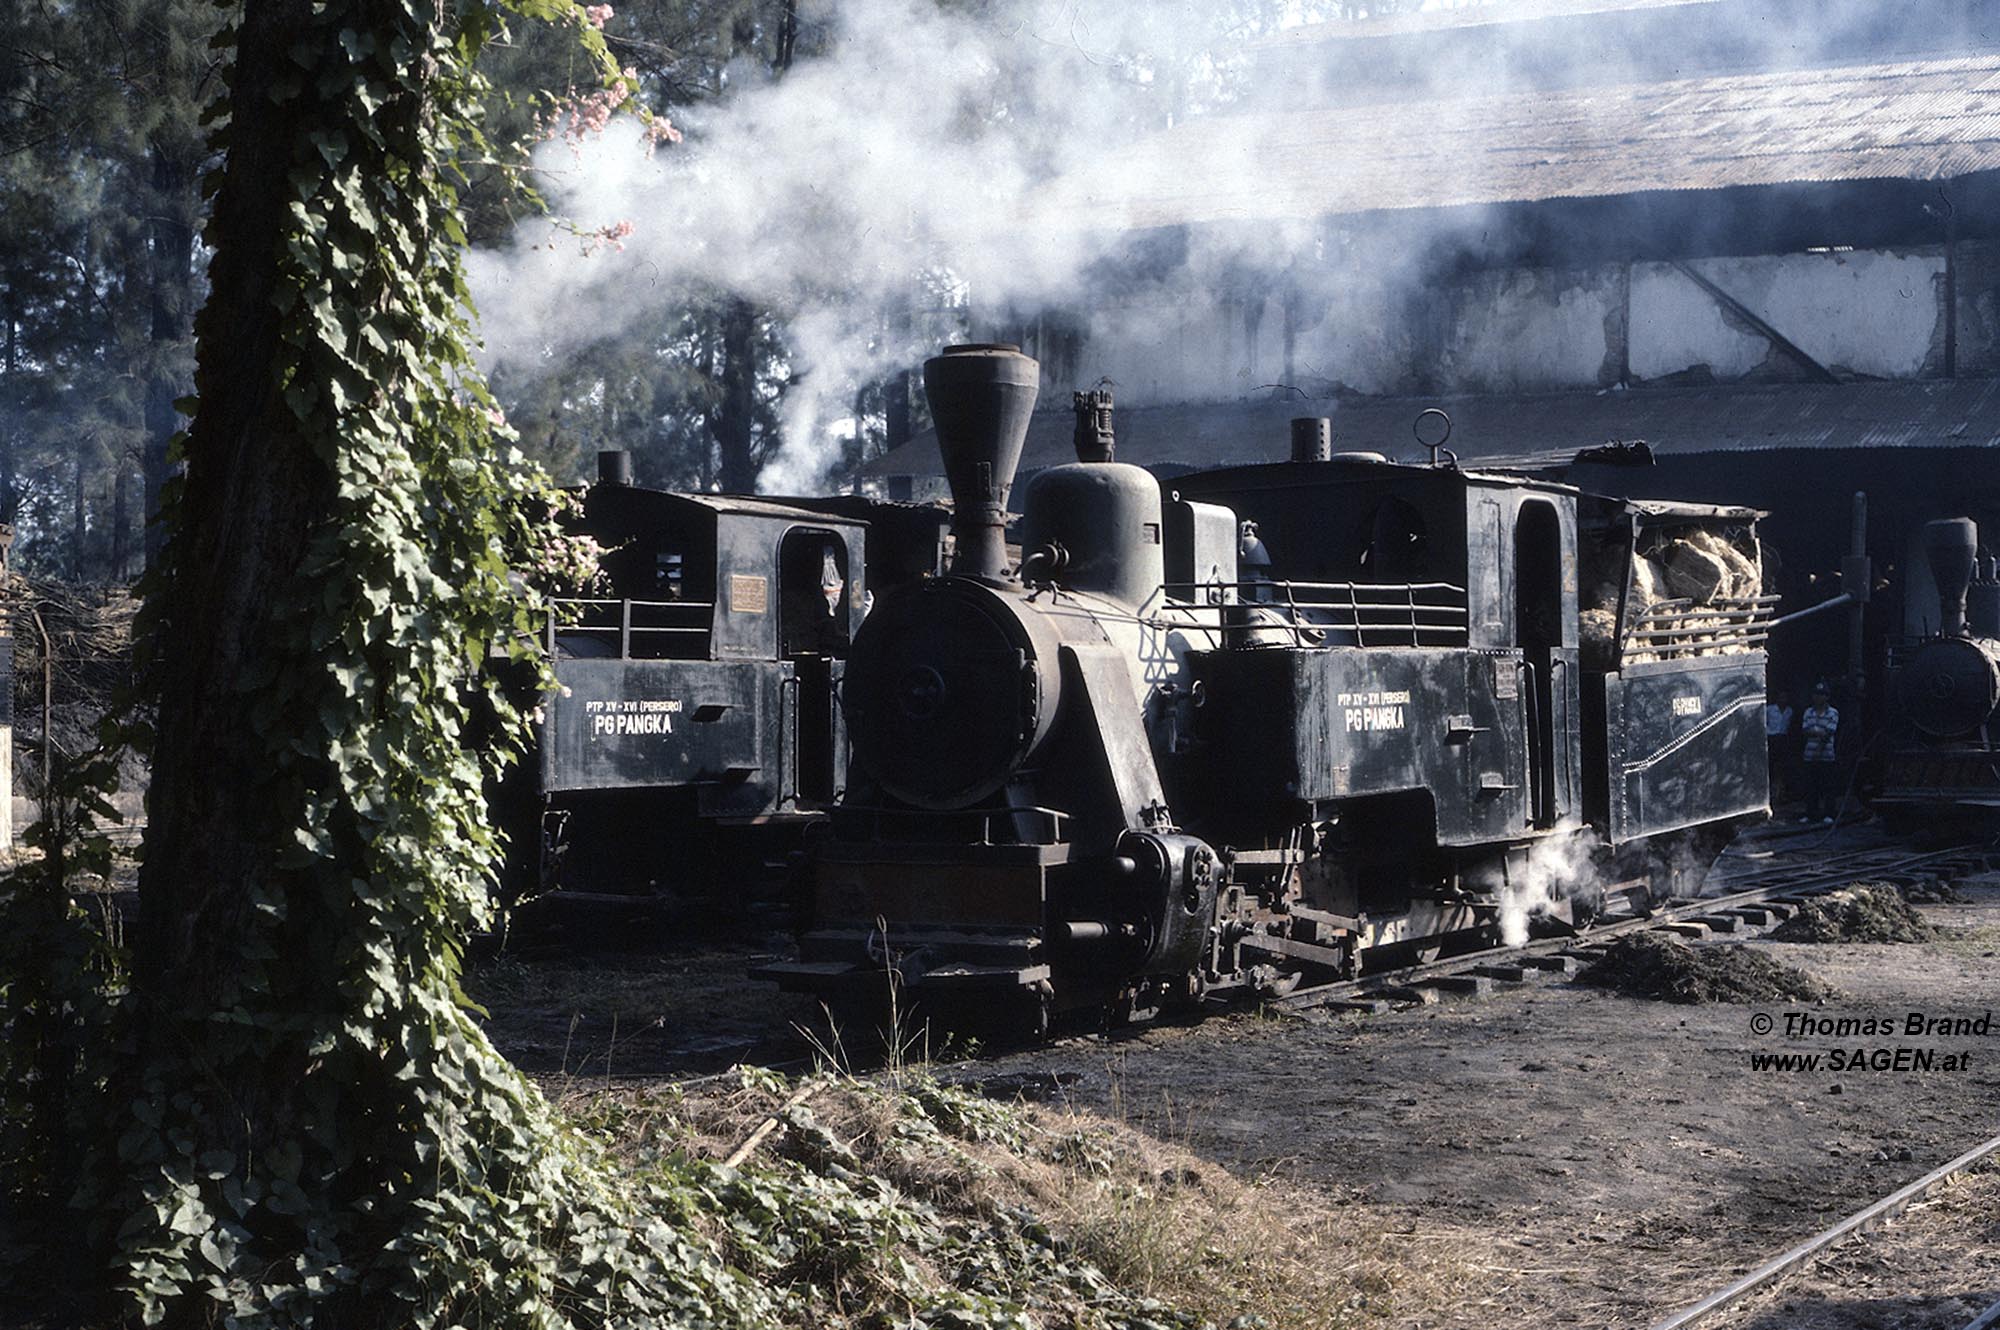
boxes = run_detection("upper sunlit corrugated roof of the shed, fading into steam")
[1040,54,2000,230]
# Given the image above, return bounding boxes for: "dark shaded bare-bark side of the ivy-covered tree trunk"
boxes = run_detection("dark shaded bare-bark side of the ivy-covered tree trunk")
[134,0,332,1088]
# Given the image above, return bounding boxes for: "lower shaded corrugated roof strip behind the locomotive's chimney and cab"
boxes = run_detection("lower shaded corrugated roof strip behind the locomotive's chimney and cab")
[862,378,2000,476]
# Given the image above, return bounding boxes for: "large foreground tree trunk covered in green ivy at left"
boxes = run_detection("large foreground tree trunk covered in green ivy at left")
[111,0,764,1328]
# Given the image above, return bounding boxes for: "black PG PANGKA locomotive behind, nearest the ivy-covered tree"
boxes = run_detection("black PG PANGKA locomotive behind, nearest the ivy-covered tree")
[512,452,946,904]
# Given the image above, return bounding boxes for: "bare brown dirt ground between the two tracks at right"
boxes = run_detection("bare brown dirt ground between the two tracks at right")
[952,832,2000,1328]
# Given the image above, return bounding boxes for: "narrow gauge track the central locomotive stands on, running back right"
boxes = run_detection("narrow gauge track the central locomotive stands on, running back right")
[1270,844,1984,1012]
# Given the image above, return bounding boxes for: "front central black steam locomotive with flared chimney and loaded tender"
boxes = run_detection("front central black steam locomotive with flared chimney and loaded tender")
[762,346,1774,1026]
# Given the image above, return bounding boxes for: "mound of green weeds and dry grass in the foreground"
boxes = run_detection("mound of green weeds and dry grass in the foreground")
[572,1038,1464,1330]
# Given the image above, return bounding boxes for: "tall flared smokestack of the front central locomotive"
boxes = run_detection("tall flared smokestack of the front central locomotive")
[924,344,1042,578]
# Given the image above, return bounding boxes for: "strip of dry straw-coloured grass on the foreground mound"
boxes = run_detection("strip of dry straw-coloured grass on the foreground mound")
[572,1070,1492,1330]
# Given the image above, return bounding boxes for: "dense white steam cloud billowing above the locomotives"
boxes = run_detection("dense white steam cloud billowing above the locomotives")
[470,0,1328,492]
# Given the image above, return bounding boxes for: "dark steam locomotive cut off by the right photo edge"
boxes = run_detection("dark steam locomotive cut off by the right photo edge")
[1872,518,2000,822]
